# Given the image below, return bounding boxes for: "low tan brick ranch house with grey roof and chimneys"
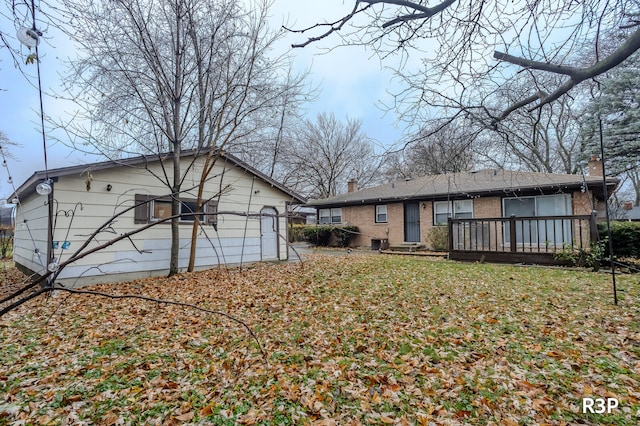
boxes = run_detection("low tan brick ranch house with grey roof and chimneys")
[307,158,618,262]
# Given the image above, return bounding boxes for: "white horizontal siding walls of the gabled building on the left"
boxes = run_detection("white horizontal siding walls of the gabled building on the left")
[16,156,291,285]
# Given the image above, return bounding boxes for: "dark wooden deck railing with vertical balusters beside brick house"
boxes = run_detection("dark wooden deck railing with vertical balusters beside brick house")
[449,214,598,263]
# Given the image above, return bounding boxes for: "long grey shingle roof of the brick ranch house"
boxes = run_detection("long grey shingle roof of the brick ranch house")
[307,170,619,206]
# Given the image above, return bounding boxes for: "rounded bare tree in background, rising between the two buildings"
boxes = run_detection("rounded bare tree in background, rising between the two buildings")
[283,113,383,198]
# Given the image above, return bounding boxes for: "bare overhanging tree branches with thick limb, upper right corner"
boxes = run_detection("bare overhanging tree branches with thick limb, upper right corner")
[291,0,640,126]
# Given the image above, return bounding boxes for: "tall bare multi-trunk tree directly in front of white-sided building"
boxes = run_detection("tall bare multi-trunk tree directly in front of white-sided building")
[53,0,302,275]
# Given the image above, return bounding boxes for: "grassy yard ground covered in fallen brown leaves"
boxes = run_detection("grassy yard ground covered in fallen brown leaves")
[0,255,640,425]
